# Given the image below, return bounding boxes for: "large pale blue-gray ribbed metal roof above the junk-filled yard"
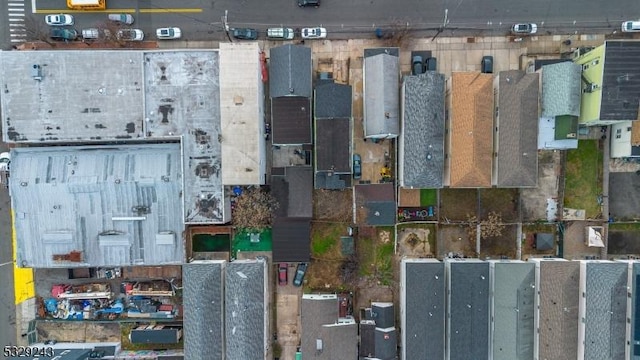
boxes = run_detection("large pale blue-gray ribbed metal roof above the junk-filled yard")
[10,143,184,267]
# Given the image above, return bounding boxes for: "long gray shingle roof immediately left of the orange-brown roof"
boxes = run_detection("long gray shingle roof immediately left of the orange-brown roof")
[399,71,445,188]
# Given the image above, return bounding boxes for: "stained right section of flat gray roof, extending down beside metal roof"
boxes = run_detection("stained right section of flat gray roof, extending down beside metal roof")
[144,51,229,224]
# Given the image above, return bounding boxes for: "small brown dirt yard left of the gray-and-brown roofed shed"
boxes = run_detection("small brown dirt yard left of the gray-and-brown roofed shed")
[313,189,353,222]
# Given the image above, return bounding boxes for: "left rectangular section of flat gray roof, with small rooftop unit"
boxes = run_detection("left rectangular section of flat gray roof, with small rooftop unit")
[0,50,144,142]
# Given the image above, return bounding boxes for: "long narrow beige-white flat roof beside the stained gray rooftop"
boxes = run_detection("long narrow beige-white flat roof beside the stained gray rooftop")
[220,42,266,185]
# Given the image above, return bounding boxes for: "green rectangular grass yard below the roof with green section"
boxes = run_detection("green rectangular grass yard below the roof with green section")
[564,140,602,219]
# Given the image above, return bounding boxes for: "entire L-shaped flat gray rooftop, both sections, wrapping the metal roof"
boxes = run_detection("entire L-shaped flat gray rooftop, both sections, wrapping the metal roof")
[0,50,230,223]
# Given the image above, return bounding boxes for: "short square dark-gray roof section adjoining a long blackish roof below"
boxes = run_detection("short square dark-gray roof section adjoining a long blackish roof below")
[314,83,352,119]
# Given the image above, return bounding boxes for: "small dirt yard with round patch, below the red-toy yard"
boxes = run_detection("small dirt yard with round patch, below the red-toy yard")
[398,225,437,257]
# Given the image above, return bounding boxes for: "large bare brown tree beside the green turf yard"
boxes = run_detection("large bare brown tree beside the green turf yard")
[233,188,279,229]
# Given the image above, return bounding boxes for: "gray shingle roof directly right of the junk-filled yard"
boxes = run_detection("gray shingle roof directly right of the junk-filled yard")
[182,261,225,360]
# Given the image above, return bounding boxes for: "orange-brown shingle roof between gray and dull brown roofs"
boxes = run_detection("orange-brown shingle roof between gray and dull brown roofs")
[449,72,493,187]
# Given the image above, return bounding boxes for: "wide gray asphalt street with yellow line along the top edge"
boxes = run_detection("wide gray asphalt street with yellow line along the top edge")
[0,0,640,48]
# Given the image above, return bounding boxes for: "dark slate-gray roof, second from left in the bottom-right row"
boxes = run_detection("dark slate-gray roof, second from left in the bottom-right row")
[445,259,489,360]
